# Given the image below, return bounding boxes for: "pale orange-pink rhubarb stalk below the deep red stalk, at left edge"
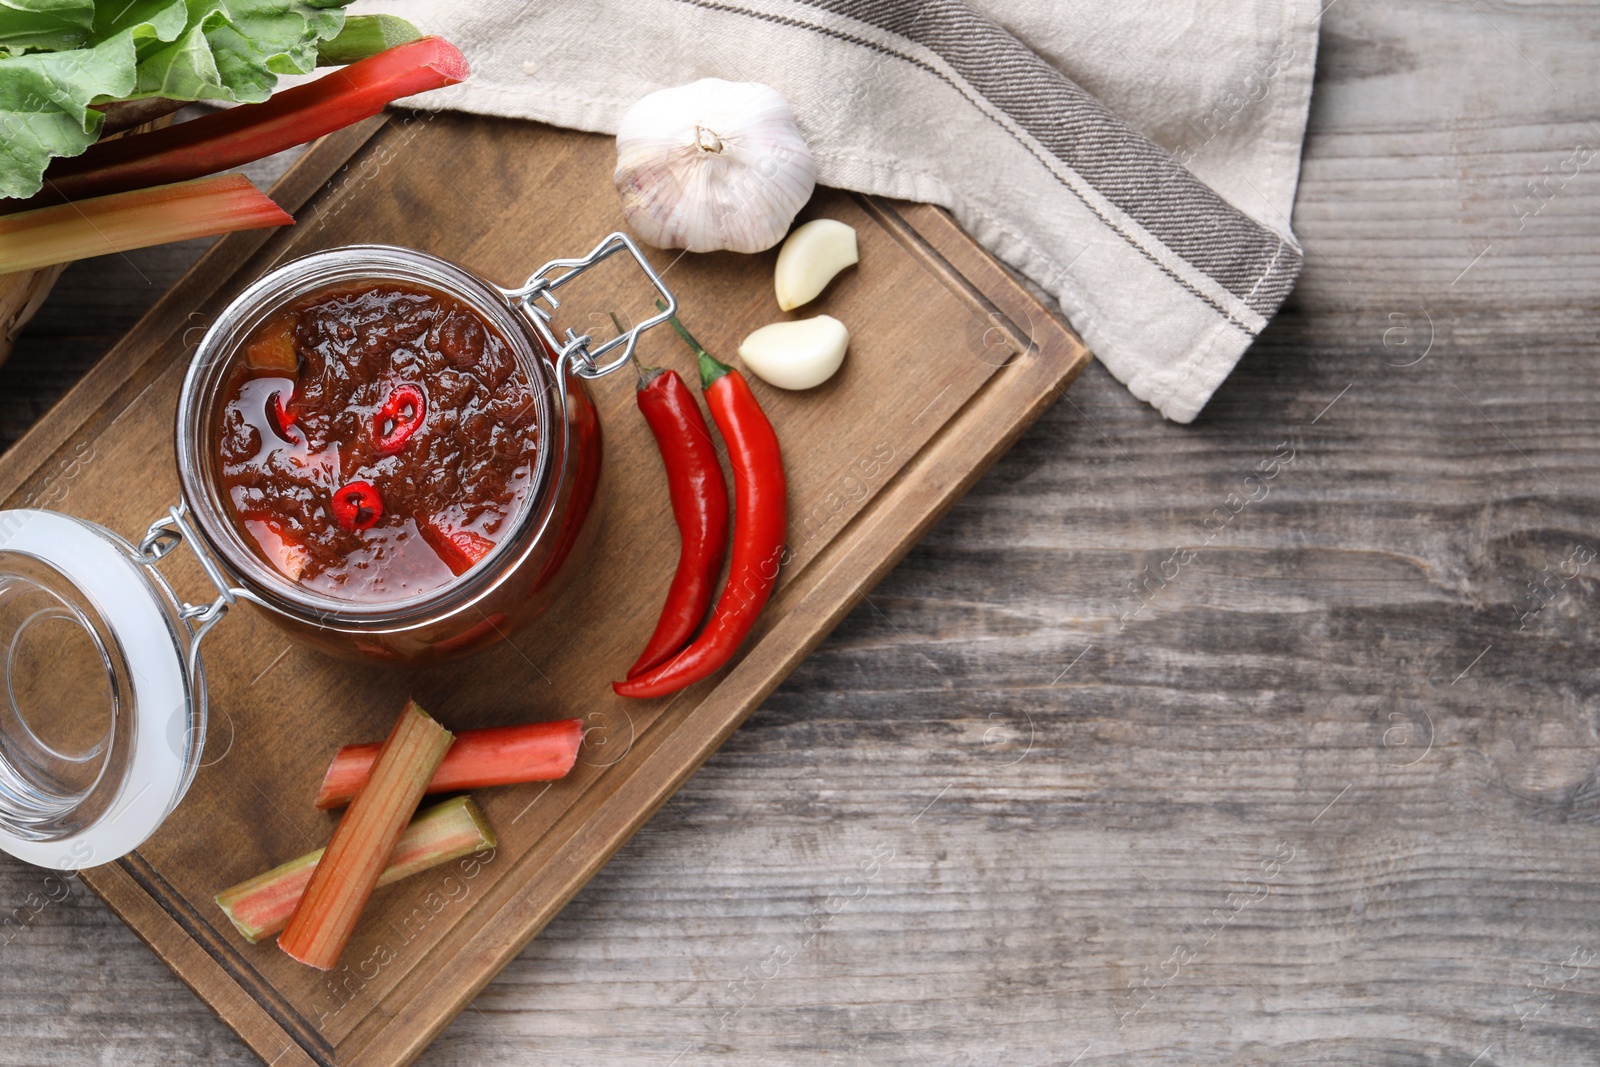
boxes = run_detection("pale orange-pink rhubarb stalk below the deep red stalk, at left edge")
[0,175,294,274]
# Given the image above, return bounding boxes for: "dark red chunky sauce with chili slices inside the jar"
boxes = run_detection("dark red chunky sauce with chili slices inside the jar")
[218,282,539,601]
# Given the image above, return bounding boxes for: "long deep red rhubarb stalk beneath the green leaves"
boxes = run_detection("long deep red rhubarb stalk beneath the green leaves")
[45,37,470,200]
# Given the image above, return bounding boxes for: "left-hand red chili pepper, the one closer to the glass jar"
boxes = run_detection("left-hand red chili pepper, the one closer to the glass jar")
[627,358,728,678]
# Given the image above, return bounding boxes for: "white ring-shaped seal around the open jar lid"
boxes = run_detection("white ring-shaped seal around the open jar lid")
[0,509,192,870]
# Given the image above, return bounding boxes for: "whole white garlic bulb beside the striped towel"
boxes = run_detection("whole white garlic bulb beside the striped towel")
[613,78,816,253]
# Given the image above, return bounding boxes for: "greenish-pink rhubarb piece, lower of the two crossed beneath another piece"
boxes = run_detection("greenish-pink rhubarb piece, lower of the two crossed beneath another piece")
[216,797,494,944]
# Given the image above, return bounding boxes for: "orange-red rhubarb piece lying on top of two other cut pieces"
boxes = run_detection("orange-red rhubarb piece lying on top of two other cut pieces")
[278,701,454,971]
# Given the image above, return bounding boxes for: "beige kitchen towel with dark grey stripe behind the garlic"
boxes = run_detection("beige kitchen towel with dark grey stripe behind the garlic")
[366,0,1320,422]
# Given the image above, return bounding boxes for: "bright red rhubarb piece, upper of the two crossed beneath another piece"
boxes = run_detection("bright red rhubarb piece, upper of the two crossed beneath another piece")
[317,718,584,808]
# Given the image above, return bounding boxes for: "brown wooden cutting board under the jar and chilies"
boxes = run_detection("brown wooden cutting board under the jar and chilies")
[0,115,1088,1067]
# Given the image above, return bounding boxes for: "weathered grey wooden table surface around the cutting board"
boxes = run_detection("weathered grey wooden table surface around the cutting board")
[0,0,1600,1067]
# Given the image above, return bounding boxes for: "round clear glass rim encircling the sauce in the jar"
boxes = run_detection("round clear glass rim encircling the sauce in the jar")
[178,245,566,629]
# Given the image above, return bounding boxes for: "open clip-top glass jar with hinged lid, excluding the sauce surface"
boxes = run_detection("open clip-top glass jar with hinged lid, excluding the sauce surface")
[0,234,677,870]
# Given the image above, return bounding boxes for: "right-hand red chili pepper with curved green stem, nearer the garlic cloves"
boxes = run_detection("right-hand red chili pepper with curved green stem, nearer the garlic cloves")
[611,318,789,696]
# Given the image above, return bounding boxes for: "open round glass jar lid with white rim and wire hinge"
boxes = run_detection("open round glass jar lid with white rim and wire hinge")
[0,509,211,870]
